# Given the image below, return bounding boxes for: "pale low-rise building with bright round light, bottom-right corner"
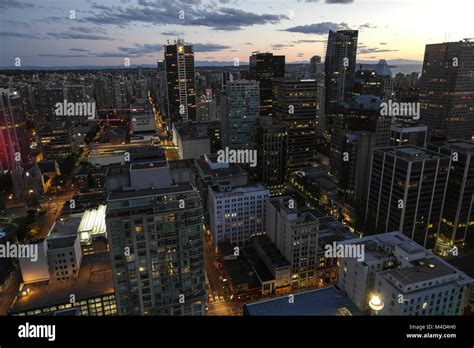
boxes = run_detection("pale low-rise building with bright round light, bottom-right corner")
[338,232,474,315]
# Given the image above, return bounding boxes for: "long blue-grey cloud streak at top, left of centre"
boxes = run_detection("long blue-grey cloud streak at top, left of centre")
[84,0,288,31]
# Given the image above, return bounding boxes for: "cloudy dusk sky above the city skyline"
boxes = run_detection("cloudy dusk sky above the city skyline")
[0,0,474,67]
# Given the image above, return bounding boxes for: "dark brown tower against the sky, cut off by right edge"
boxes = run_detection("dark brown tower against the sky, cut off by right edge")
[419,39,474,141]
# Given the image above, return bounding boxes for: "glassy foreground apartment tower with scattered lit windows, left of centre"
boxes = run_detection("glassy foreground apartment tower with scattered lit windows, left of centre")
[106,184,206,315]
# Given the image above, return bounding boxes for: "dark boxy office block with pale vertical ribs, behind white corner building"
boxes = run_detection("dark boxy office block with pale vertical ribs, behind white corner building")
[365,145,451,249]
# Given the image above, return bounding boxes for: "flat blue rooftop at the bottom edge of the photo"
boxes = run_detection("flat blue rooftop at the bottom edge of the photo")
[244,286,362,316]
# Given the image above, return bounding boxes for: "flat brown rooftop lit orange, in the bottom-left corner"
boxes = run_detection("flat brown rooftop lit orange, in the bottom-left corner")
[9,253,114,314]
